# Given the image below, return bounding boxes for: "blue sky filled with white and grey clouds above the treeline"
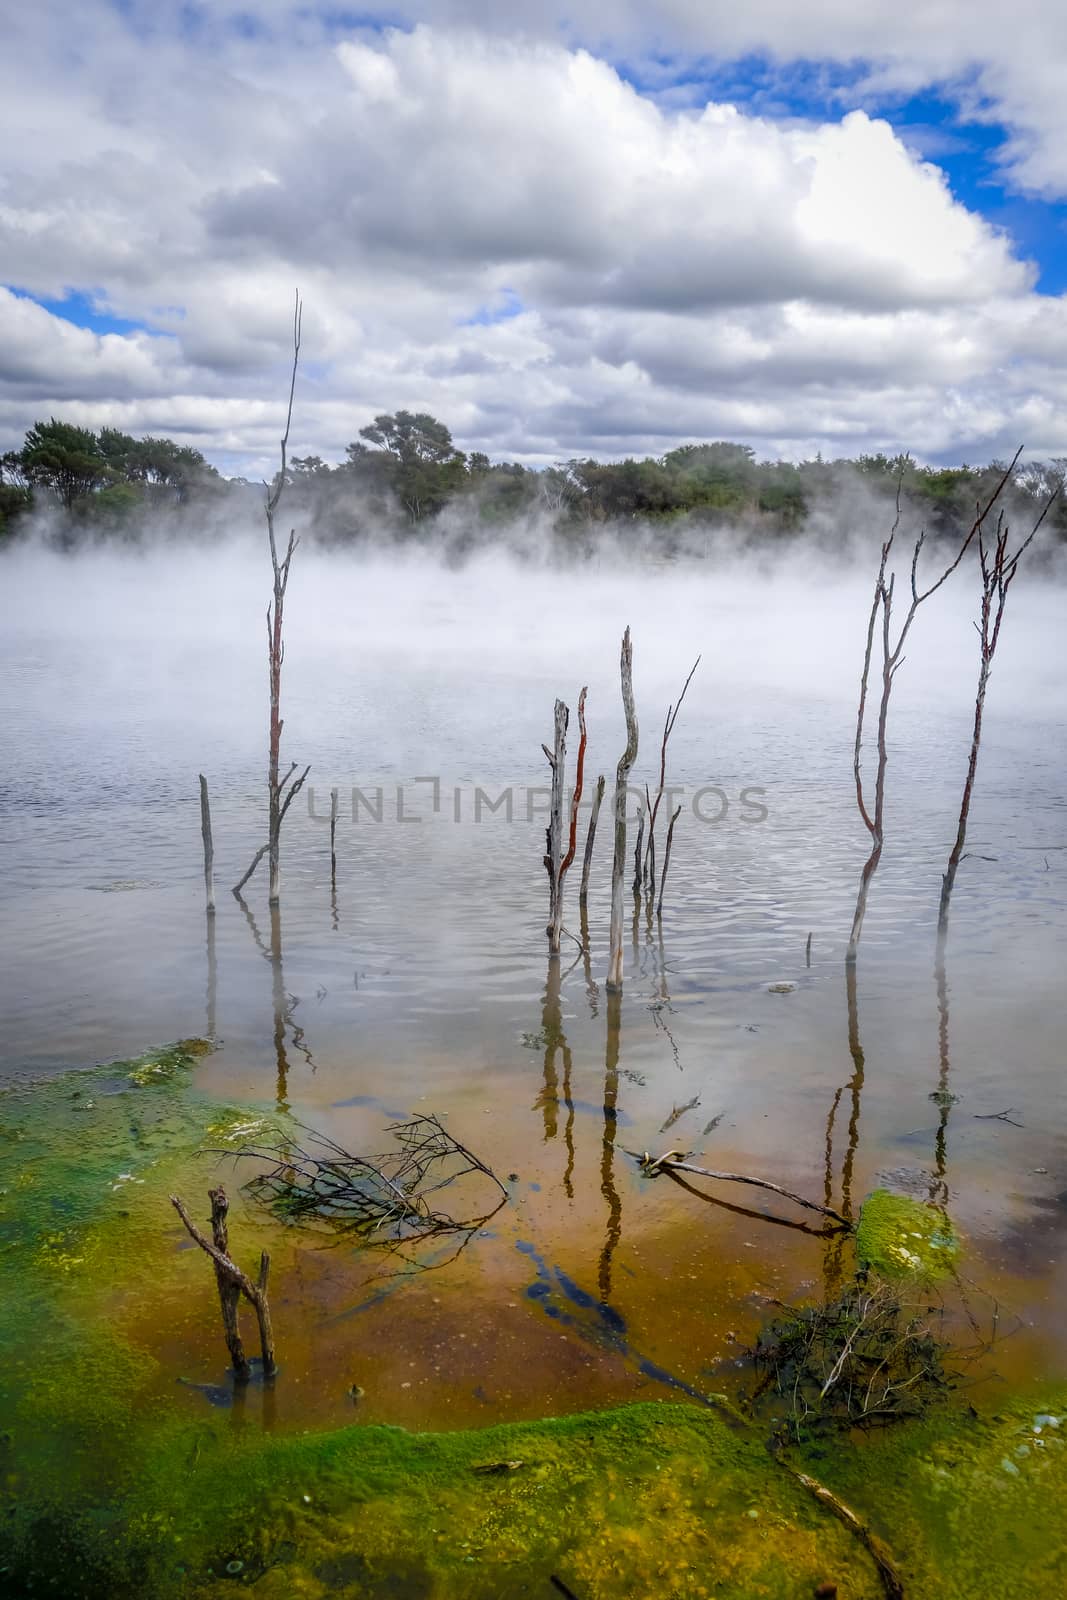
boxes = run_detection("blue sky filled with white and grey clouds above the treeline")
[0,0,1067,478]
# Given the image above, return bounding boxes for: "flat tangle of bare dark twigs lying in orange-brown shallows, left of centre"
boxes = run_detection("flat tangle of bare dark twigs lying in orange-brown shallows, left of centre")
[230,1117,507,1242]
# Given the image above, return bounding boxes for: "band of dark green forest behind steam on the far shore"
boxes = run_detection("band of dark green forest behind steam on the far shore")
[0,411,1067,555]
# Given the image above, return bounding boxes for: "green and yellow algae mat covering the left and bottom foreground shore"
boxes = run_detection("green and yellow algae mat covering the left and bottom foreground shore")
[0,1046,1067,1600]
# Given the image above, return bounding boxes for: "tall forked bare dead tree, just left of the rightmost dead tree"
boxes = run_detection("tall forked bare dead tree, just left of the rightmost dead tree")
[845,450,1022,962]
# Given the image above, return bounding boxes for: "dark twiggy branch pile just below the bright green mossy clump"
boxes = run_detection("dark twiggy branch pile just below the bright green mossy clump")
[752,1283,949,1438]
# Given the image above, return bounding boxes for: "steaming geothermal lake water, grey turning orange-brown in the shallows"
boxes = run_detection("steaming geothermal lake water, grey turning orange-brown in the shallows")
[0,542,1067,1429]
